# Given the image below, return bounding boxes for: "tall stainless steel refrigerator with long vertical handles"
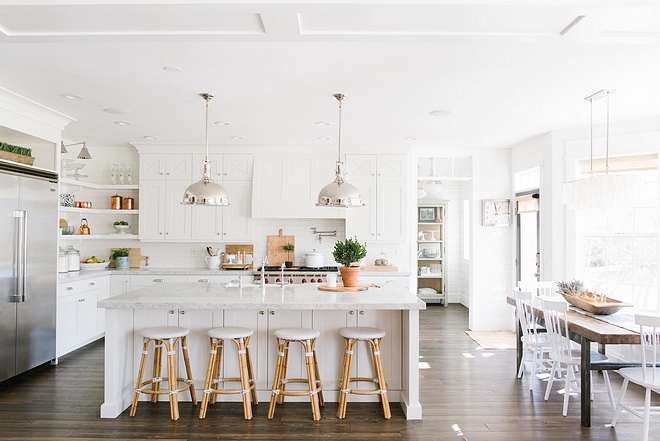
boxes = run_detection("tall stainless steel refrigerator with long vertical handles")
[0,160,59,381]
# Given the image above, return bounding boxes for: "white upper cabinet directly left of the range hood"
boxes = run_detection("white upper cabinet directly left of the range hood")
[192,154,254,242]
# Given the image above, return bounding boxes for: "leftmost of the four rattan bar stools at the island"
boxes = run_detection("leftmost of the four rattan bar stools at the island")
[130,326,197,420]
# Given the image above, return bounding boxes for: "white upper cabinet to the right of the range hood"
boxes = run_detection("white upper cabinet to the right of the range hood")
[346,155,409,242]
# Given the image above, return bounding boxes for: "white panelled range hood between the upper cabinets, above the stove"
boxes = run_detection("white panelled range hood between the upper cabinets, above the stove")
[252,154,346,219]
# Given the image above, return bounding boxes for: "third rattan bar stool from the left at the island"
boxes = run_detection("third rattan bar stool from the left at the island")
[268,328,324,421]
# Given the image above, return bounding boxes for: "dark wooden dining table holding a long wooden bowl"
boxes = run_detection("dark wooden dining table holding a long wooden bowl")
[507,296,640,427]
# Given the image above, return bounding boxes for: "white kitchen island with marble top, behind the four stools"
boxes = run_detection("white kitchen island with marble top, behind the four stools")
[98,283,425,419]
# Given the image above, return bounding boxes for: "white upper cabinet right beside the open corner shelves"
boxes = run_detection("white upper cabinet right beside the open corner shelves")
[139,153,192,241]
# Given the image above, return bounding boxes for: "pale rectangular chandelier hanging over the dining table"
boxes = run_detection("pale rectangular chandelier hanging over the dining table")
[563,89,632,209]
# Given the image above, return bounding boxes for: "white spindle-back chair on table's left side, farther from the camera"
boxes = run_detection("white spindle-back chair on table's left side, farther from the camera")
[513,289,553,390]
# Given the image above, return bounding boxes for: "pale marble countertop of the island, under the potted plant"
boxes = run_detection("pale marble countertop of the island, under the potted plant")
[98,282,426,310]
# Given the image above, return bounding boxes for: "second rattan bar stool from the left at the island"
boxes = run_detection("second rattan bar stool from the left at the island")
[199,326,259,420]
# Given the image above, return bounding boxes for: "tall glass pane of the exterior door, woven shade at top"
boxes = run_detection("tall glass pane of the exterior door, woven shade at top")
[516,190,541,282]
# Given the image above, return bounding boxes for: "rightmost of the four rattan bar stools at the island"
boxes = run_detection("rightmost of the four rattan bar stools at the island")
[337,327,392,420]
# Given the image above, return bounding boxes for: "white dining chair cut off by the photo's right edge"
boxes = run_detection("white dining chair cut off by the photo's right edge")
[612,314,660,441]
